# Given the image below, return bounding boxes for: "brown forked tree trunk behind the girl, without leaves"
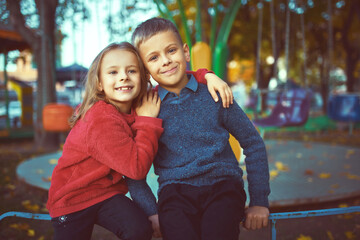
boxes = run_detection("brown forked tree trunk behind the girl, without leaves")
[6,0,59,149]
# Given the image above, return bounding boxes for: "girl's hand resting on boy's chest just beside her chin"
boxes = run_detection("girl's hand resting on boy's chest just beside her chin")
[136,89,161,117]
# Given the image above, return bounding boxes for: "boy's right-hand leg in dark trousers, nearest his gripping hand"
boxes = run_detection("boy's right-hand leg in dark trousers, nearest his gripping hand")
[201,181,246,240]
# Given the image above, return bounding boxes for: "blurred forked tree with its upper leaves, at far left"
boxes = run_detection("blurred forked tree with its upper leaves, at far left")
[0,0,87,148]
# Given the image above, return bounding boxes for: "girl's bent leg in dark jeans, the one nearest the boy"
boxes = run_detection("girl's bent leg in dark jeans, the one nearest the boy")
[96,195,153,240]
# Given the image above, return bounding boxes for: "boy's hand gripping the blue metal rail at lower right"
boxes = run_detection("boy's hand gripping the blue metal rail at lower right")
[244,206,270,230]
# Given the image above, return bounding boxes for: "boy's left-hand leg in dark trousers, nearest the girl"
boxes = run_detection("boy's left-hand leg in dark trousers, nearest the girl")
[159,184,200,240]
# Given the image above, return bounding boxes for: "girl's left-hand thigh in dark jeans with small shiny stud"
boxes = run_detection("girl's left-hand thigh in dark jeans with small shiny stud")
[51,206,97,240]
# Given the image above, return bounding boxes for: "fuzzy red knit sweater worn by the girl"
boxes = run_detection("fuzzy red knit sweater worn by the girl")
[46,69,208,217]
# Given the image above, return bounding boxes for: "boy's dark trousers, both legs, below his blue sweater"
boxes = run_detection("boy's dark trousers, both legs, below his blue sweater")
[159,180,246,240]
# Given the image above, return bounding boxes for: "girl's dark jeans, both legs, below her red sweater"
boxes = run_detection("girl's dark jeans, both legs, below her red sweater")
[51,195,152,240]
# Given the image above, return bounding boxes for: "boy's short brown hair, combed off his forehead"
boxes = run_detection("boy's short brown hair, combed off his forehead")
[131,18,183,48]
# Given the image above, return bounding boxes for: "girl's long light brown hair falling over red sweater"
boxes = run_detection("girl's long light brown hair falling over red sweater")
[69,42,151,127]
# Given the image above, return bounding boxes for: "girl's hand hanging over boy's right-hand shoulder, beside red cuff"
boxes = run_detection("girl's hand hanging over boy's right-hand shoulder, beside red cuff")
[205,73,234,108]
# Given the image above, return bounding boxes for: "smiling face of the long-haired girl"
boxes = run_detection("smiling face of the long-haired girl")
[99,49,141,113]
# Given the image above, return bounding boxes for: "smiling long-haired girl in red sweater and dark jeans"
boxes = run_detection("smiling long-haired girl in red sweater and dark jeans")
[47,42,163,240]
